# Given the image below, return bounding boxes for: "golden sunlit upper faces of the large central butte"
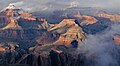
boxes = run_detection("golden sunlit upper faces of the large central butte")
[50,19,85,45]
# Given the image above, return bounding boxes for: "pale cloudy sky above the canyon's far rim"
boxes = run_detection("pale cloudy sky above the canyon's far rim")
[0,0,120,11]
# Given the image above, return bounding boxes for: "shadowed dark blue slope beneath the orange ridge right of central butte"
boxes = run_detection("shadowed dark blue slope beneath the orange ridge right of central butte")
[81,17,113,34]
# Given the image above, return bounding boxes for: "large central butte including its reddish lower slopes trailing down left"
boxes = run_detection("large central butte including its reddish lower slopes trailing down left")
[29,19,86,57]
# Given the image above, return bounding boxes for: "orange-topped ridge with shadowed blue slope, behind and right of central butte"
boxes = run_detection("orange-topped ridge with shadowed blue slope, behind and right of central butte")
[74,12,113,34]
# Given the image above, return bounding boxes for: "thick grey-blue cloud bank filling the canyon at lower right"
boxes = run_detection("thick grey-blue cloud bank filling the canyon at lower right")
[78,24,120,66]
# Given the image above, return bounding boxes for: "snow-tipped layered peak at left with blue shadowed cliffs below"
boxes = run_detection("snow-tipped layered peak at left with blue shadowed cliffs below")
[0,4,50,41]
